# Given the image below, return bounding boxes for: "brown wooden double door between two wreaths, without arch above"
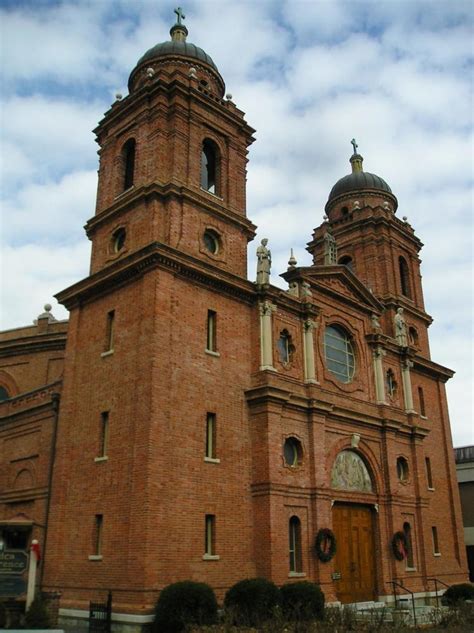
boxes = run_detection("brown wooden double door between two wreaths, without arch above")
[332,504,377,603]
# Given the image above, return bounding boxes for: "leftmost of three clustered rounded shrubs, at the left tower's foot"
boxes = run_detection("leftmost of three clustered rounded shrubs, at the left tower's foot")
[153,580,217,633]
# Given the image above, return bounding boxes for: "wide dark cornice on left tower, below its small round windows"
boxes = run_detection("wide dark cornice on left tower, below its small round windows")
[55,242,257,310]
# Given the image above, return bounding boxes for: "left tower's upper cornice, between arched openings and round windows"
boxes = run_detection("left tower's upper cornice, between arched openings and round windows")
[84,182,257,240]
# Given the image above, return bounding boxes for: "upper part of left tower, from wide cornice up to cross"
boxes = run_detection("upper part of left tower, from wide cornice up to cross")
[86,9,254,277]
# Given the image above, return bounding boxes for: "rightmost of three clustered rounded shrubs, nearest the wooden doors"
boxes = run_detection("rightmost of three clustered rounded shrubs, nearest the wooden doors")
[280,580,324,621]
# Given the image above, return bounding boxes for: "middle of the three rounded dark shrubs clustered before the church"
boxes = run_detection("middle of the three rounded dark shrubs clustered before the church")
[224,578,280,626]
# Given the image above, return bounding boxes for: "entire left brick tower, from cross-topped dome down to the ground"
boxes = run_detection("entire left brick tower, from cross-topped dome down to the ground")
[44,9,255,612]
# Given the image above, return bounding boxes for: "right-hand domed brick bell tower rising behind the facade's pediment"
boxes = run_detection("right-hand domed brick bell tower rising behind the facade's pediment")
[308,139,432,355]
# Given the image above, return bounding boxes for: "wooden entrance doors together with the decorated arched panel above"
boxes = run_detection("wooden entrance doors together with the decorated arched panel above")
[331,450,377,604]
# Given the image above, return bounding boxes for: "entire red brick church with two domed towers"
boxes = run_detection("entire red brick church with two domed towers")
[0,15,467,631]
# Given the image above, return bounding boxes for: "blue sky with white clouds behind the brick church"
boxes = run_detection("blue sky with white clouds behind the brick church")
[0,0,474,446]
